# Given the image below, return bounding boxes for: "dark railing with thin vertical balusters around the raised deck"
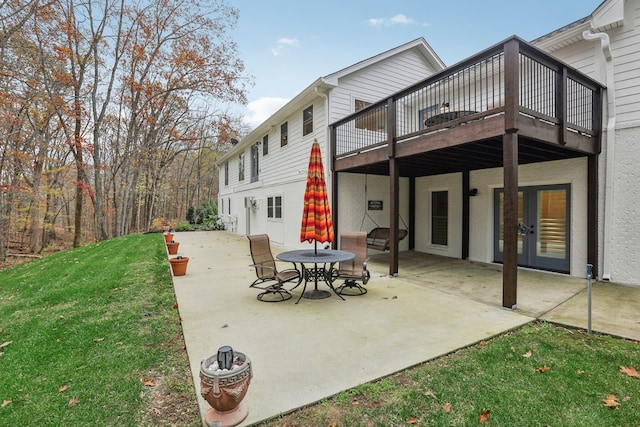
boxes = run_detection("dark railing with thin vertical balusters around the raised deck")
[332,37,602,158]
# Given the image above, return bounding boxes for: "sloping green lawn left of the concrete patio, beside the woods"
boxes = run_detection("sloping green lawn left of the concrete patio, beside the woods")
[0,234,201,426]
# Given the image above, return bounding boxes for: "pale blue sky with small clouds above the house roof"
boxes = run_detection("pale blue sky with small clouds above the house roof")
[227,0,602,128]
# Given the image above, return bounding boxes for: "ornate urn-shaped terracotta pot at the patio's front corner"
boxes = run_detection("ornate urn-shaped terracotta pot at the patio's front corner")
[200,351,253,426]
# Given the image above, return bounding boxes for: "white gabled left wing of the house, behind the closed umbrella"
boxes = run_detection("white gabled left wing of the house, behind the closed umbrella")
[218,38,444,247]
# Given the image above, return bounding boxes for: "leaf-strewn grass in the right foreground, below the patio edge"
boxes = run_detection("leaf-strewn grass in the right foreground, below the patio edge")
[260,323,640,427]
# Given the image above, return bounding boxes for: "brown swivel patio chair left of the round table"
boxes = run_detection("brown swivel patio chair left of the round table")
[247,234,302,302]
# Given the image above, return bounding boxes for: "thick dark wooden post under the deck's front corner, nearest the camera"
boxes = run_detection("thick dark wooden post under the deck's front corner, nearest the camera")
[502,132,518,309]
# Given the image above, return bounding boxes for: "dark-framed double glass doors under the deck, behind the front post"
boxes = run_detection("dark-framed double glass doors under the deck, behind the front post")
[493,184,571,273]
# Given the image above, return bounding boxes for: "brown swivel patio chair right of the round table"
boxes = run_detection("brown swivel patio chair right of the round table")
[332,231,371,296]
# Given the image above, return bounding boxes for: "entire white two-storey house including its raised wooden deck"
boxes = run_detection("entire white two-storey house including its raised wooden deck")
[219,0,640,307]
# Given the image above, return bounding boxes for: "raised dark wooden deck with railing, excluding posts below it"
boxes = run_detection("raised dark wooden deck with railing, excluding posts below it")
[331,37,604,177]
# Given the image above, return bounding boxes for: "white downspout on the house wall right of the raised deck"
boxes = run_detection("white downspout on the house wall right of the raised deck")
[582,30,616,280]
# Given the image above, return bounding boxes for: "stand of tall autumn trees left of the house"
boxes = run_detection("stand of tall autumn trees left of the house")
[0,0,249,251]
